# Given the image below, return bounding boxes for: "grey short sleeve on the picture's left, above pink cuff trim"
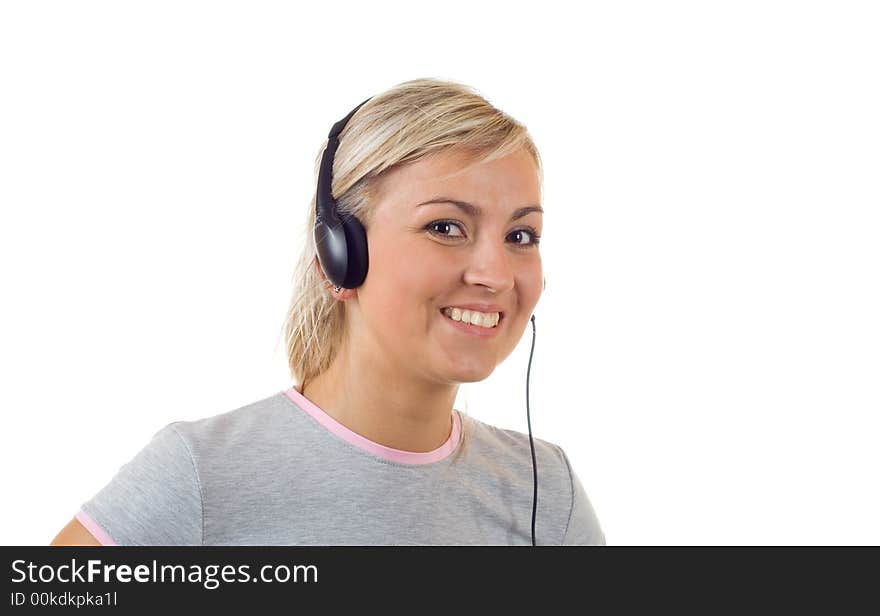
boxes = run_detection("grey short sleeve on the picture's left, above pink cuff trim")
[76,423,203,546]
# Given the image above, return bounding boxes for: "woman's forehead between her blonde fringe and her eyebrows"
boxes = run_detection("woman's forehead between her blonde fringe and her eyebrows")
[376,149,541,215]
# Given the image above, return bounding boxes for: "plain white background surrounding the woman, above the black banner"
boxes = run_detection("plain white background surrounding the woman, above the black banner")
[0,0,880,545]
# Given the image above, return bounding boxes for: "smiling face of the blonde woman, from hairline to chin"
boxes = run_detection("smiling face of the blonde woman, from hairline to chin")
[346,150,543,384]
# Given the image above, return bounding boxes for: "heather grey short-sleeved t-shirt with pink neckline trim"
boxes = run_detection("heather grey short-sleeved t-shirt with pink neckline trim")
[76,388,605,545]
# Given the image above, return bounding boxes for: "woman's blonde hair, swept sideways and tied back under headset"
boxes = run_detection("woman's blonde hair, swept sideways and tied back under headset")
[283,78,543,452]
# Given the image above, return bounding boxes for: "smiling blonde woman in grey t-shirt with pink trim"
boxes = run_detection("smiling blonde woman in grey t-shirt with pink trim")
[53,79,605,545]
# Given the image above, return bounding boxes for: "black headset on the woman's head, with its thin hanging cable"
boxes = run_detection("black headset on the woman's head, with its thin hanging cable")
[315,97,538,546]
